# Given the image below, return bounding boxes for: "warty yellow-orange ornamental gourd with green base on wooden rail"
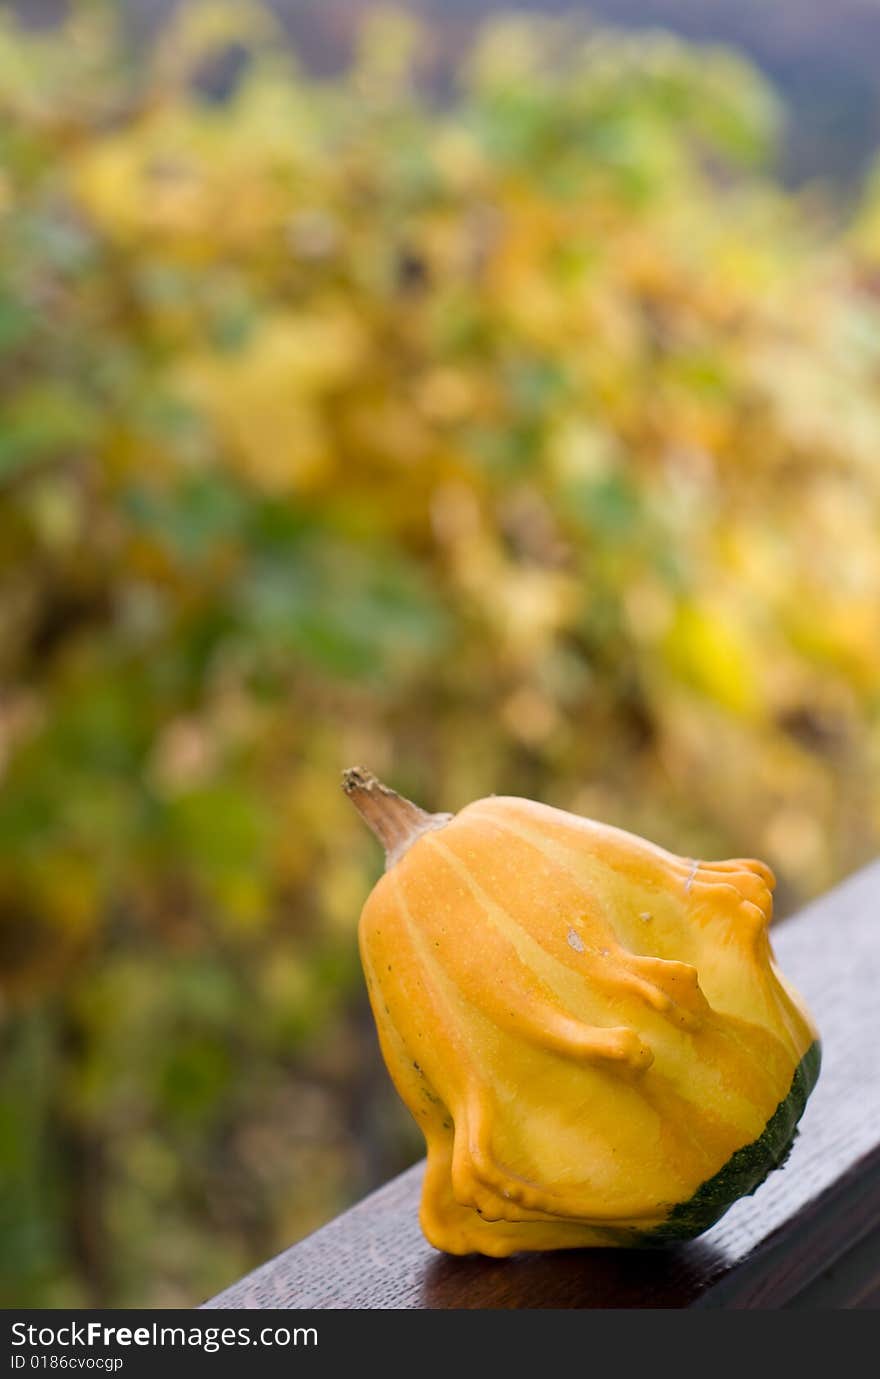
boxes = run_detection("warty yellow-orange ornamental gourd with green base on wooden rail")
[343,768,819,1255]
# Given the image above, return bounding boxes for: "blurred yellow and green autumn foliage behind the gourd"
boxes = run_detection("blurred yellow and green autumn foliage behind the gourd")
[0,0,880,1306]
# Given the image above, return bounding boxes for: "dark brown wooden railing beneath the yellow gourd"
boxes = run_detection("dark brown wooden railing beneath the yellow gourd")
[206,863,880,1309]
